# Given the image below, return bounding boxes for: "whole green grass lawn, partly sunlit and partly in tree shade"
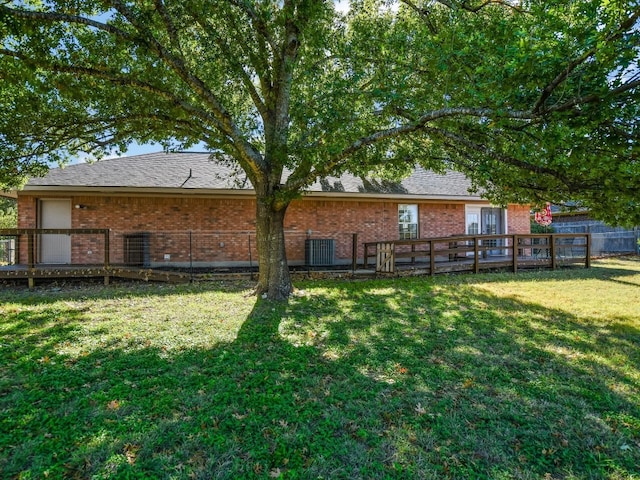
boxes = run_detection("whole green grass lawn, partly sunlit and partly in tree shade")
[0,258,640,479]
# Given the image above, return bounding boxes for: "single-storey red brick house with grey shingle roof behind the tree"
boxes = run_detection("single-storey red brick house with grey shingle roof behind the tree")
[17,153,530,266]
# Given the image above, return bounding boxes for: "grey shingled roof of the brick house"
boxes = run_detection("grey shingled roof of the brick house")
[23,152,481,200]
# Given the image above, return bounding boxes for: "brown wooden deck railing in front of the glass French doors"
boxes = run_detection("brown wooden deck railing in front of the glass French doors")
[364,233,591,275]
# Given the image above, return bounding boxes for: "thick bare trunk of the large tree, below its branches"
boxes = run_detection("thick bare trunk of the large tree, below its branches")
[256,198,293,300]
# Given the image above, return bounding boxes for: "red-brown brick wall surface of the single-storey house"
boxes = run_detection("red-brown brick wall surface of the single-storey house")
[18,194,529,265]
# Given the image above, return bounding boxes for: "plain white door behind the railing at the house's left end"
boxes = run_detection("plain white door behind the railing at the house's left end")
[40,199,71,264]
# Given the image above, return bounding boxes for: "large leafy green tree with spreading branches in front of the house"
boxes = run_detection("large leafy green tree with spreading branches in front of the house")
[0,0,640,298]
